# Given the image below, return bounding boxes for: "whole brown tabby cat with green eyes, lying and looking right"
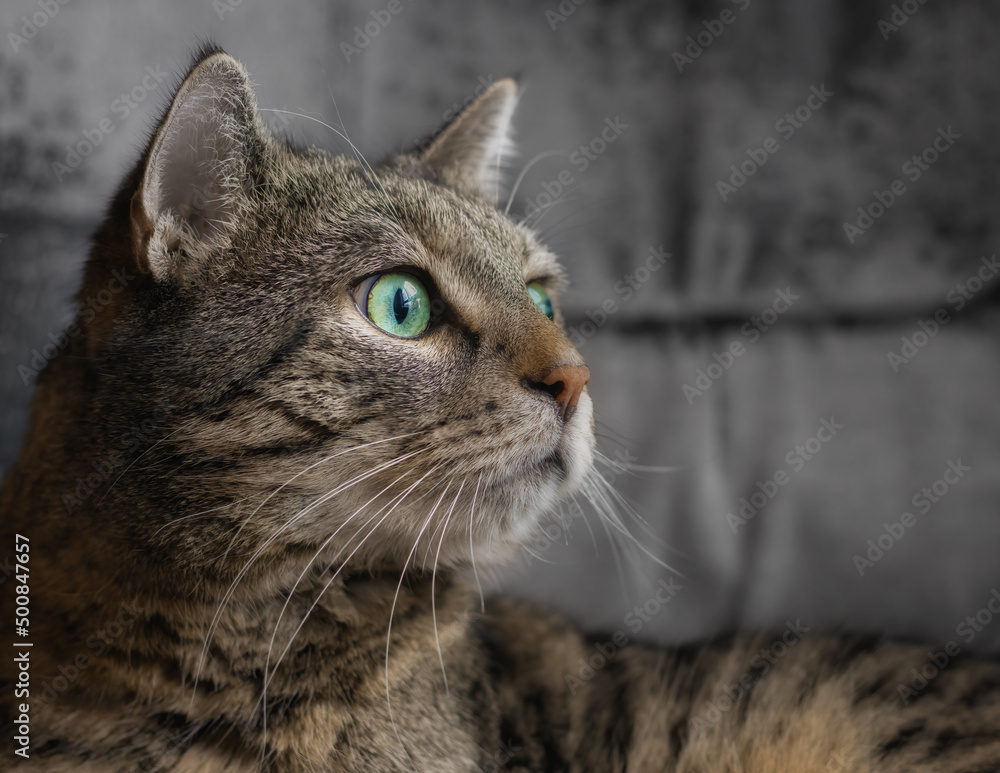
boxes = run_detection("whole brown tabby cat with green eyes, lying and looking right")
[0,48,1000,773]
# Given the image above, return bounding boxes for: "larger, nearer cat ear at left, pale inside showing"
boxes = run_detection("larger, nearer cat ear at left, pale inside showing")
[130,51,269,284]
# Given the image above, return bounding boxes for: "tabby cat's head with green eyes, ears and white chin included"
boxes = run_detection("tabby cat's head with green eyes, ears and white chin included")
[82,51,594,584]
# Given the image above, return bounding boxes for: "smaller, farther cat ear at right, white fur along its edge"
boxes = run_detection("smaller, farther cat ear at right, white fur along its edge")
[419,78,517,202]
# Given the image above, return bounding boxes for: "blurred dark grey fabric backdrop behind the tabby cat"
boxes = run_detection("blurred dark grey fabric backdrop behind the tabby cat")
[0,0,1000,651]
